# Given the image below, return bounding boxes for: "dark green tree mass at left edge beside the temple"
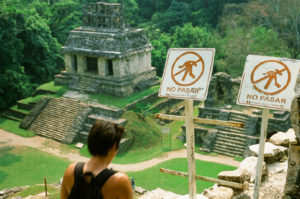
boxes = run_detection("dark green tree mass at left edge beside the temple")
[0,0,63,109]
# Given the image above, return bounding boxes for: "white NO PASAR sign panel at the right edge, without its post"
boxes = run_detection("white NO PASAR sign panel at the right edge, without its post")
[237,55,300,110]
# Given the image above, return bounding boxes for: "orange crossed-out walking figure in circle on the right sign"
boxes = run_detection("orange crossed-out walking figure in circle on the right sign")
[251,60,291,95]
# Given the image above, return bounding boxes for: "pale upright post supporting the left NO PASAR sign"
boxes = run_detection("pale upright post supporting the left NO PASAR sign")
[185,100,196,199]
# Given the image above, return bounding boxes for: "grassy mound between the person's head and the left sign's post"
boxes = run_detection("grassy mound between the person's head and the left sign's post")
[80,111,183,164]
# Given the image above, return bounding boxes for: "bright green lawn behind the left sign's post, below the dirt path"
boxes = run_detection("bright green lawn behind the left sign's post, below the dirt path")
[127,158,236,194]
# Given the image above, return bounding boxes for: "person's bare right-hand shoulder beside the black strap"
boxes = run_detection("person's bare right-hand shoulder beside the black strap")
[102,172,132,199]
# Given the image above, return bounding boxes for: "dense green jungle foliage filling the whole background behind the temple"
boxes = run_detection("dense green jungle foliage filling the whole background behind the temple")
[0,0,300,110]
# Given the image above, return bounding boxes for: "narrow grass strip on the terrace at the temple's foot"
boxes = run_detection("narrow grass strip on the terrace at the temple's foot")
[89,85,160,108]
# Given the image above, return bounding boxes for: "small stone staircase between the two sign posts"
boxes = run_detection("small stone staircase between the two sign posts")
[213,111,249,157]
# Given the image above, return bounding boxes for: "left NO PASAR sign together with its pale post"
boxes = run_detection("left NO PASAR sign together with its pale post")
[159,48,215,199]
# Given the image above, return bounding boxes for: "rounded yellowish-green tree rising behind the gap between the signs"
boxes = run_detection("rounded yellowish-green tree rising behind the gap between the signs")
[215,27,289,77]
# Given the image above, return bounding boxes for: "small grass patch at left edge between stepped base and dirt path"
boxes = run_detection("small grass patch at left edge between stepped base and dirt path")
[0,117,35,137]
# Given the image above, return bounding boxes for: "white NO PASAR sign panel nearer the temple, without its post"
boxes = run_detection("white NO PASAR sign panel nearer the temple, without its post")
[158,48,215,100]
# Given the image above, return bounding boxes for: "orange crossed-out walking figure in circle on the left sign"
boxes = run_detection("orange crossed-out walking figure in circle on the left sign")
[171,52,204,86]
